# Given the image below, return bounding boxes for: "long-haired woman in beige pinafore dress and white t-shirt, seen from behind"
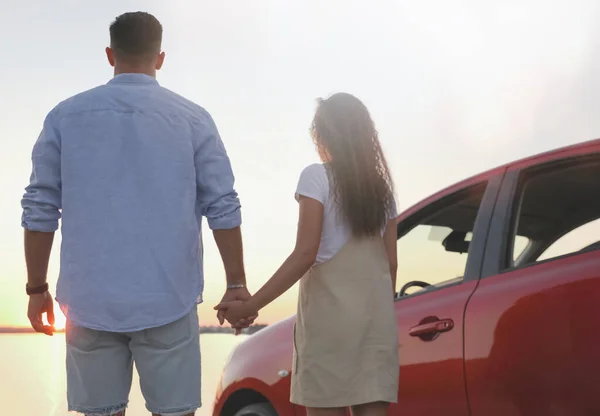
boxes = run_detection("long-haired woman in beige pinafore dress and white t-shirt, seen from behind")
[215,94,399,416]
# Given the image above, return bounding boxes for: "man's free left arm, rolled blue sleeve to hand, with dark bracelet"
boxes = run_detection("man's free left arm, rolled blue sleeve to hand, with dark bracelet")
[21,112,62,335]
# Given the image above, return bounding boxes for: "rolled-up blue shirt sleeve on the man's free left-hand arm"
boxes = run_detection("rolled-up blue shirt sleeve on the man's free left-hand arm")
[21,111,62,232]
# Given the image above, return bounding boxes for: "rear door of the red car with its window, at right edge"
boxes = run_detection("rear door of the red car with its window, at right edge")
[465,145,600,416]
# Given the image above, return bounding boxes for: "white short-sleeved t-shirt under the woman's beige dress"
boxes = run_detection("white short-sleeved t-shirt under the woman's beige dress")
[296,163,398,263]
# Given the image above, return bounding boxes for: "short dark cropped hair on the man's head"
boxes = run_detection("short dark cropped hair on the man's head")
[109,12,162,60]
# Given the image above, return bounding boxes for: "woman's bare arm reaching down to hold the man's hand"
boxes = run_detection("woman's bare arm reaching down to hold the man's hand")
[215,196,323,323]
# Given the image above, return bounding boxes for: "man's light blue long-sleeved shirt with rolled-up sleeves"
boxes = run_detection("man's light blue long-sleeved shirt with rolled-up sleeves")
[22,74,241,332]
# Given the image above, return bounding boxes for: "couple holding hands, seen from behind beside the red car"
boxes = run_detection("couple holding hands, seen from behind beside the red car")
[21,12,399,416]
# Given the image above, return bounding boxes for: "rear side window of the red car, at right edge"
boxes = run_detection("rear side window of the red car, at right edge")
[505,157,600,268]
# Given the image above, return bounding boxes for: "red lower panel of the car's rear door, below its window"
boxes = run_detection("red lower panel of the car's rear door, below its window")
[465,251,600,416]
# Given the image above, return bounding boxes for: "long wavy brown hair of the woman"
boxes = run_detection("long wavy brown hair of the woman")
[311,93,395,237]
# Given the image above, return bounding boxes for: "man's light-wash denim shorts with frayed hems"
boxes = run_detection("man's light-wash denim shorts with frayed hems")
[66,307,201,416]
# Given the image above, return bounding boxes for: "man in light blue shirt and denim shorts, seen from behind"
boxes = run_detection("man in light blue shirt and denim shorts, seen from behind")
[22,12,251,416]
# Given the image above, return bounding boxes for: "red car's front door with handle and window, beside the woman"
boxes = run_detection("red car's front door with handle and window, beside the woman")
[390,169,503,416]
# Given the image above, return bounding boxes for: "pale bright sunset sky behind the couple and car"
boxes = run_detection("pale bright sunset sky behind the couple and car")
[0,0,600,326]
